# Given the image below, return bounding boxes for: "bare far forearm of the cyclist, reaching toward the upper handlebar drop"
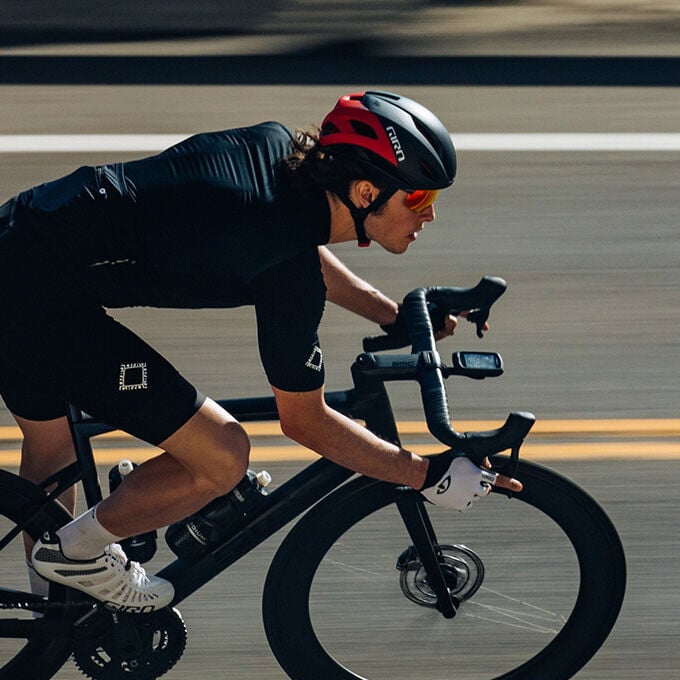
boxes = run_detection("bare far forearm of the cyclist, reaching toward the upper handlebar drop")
[319,246,398,324]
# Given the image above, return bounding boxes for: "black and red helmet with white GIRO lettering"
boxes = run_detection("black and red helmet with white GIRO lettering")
[319,90,456,191]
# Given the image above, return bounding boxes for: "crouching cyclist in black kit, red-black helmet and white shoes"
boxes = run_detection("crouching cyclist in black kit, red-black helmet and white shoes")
[0,91,521,612]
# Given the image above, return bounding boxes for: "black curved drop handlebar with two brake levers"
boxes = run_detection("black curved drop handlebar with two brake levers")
[359,276,536,466]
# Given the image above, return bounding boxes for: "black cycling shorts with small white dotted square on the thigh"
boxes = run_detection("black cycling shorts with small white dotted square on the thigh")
[0,197,205,445]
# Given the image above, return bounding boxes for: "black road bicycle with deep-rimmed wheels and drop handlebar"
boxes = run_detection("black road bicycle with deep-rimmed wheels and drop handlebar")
[0,277,626,680]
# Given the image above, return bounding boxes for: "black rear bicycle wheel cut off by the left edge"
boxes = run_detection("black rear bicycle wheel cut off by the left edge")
[0,470,74,680]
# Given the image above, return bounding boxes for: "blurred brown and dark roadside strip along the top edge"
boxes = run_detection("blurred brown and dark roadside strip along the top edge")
[0,0,680,56]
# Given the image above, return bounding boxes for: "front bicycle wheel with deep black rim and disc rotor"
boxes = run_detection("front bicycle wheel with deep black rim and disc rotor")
[263,461,626,680]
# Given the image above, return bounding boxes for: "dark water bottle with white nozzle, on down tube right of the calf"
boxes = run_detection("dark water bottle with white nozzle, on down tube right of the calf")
[165,470,272,558]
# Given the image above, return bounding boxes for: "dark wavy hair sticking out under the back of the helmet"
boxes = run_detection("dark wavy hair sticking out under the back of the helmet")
[286,127,390,195]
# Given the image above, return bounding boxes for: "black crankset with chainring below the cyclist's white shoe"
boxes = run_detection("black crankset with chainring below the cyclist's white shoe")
[73,607,187,680]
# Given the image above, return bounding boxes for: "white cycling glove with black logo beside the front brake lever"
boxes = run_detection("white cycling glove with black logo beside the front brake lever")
[420,456,498,512]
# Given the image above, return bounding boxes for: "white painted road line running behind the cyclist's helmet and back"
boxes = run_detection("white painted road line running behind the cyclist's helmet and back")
[0,132,680,153]
